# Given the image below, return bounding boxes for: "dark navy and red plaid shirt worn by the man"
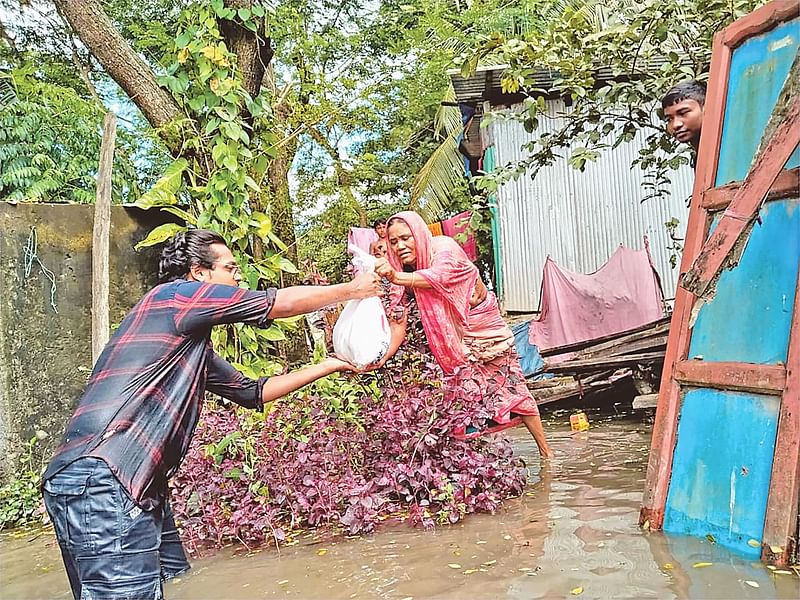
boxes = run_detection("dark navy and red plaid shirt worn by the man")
[43,279,276,509]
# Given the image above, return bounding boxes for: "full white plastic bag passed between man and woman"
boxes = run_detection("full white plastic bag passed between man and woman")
[333,245,392,369]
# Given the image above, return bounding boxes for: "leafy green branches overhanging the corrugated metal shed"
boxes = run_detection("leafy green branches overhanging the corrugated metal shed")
[463,0,764,199]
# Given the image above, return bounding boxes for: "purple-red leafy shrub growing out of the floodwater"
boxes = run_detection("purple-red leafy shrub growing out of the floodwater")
[171,302,525,552]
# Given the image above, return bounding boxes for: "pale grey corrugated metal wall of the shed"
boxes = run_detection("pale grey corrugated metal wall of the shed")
[490,100,694,312]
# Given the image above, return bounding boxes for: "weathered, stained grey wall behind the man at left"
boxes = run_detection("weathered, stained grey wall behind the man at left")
[0,202,173,480]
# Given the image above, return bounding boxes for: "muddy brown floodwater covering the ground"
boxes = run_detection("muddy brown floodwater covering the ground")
[0,417,800,600]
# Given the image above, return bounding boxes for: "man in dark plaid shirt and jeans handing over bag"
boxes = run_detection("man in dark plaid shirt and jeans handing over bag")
[43,229,380,599]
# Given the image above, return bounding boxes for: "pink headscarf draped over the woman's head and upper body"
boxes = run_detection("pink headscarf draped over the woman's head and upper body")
[387,211,478,373]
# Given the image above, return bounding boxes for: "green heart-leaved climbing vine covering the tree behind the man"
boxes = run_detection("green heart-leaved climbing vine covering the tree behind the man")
[138,0,298,377]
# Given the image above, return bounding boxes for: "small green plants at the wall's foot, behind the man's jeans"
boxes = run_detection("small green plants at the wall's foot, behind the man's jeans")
[0,436,44,529]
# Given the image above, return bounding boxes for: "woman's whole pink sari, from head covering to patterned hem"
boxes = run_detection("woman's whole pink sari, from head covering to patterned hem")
[388,211,539,438]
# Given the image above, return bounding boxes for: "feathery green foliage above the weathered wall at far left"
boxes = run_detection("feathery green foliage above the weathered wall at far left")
[0,63,139,203]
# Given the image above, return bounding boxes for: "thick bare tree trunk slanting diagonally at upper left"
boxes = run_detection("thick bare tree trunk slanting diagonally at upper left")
[55,0,182,128]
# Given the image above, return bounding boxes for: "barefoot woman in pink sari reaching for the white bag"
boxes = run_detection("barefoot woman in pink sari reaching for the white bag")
[375,211,552,457]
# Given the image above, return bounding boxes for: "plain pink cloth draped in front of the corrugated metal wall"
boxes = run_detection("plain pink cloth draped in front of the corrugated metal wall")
[528,238,664,360]
